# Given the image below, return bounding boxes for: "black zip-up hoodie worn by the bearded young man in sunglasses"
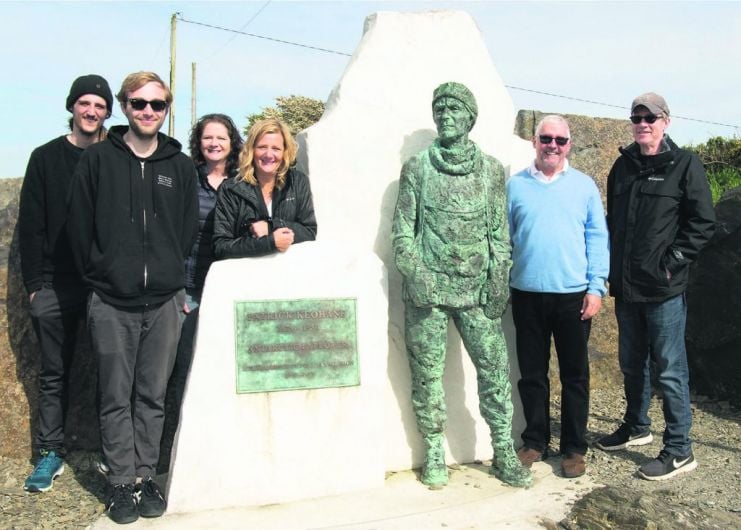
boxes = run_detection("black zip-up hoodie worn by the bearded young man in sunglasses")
[67,126,198,307]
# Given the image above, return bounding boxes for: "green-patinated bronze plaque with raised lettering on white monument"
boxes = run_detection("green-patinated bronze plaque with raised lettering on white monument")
[234,298,360,394]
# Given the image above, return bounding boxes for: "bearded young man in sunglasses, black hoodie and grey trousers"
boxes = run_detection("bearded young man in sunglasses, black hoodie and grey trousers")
[67,72,198,523]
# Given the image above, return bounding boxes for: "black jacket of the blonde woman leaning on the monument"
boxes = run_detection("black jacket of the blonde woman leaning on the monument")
[213,169,317,259]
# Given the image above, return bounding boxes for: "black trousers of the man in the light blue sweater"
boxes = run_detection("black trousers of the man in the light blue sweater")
[512,289,591,454]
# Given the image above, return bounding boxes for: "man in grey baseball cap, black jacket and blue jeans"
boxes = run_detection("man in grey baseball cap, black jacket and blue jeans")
[595,92,715,480]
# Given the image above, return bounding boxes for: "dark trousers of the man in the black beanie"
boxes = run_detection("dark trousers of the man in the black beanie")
[30,285,86,451]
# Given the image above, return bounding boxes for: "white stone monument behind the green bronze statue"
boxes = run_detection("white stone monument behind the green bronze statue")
[168,11,533,512]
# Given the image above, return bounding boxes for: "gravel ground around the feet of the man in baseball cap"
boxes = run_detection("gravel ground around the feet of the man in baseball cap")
[554,390,741,530]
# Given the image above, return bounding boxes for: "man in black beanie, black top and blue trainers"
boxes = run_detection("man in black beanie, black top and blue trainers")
[18,74,113,492]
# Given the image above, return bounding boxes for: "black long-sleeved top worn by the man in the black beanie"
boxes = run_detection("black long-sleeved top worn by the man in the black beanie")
[18,136,83,294]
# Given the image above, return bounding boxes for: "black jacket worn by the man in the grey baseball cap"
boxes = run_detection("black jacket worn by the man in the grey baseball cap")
[607,136,715,302]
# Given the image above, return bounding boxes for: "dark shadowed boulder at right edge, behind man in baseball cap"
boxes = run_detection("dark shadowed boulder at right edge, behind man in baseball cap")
[687,187,741,406]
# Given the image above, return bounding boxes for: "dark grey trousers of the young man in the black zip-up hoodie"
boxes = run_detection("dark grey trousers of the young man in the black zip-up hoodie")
[88,291,185,484]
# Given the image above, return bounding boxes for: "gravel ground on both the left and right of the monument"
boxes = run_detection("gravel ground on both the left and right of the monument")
[0,384,741,530]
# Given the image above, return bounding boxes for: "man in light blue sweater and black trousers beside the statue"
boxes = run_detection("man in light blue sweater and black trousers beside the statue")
[507,115,609,478]
